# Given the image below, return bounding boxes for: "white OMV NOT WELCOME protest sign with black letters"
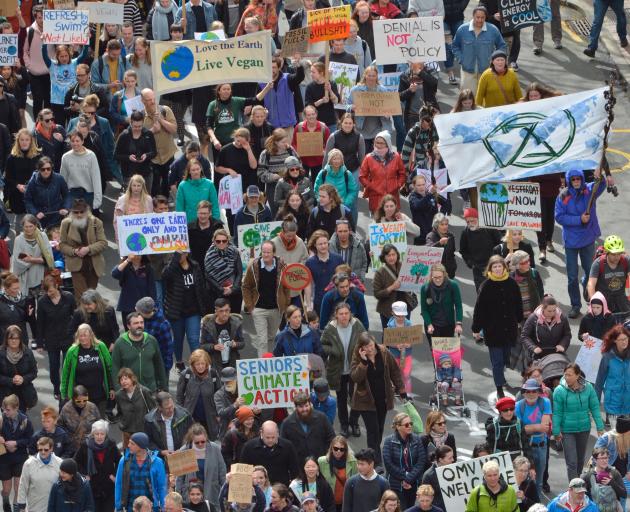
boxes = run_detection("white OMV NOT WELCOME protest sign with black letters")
[436,452,516,512]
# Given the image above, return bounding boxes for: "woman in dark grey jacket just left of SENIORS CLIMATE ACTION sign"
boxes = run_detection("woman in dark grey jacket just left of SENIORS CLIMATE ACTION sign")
[176,349,221,439]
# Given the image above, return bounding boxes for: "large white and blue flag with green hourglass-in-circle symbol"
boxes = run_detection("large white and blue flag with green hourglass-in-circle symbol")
[434,87,608,191]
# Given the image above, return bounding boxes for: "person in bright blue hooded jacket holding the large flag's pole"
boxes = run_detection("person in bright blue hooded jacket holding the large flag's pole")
[555,169,606,318]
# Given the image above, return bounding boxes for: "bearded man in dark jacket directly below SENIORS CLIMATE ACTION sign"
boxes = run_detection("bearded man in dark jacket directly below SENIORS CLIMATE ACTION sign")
[280,392,335,460]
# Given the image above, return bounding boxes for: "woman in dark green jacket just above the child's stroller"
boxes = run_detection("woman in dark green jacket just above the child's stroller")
[420,263,463,346]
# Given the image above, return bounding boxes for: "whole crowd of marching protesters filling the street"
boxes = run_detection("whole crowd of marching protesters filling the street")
[0,0,630,512]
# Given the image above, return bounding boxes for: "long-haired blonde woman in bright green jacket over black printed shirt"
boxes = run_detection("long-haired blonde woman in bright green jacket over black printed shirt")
[60,324,114,417]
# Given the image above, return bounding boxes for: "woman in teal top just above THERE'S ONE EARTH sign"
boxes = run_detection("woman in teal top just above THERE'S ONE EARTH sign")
[175,158,221,223]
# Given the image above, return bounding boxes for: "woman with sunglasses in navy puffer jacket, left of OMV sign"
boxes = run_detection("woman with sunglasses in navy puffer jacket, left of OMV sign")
[383,412,428,510]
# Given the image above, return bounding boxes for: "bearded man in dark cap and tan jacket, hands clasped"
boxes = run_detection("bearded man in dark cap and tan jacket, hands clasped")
[59,199,107,302]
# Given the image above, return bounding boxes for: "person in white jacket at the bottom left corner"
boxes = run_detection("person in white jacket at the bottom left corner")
[17,437,63,512]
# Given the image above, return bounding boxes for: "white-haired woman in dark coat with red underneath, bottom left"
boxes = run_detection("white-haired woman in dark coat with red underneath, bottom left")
[74,420,121,512]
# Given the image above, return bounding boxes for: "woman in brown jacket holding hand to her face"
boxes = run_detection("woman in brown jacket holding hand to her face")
[350,332,407,463]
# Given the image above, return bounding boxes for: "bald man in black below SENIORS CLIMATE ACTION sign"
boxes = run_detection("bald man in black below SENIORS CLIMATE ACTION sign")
[239,420,302,485]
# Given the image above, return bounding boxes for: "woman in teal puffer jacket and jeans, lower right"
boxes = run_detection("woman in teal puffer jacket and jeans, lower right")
[552,363,604,481]
